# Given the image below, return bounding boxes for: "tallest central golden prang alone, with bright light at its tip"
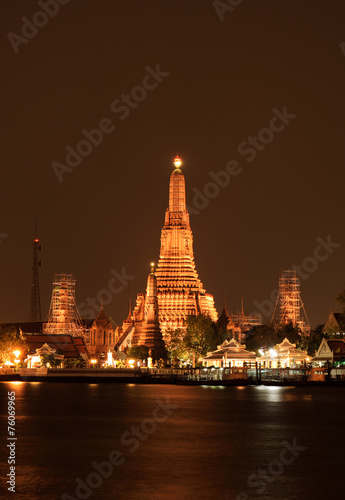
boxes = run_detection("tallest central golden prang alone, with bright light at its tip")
[155,156,218,338]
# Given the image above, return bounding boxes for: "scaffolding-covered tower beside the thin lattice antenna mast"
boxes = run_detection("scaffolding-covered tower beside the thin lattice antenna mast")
[43,273,85,337]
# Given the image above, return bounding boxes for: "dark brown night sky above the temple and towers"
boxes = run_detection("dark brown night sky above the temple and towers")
[0,0,345,326]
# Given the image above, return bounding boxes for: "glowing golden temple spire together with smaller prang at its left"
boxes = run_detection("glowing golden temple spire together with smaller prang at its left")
[116,157,218,351]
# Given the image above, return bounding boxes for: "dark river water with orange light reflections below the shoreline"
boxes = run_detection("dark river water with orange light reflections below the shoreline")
[0,382,345,500]
